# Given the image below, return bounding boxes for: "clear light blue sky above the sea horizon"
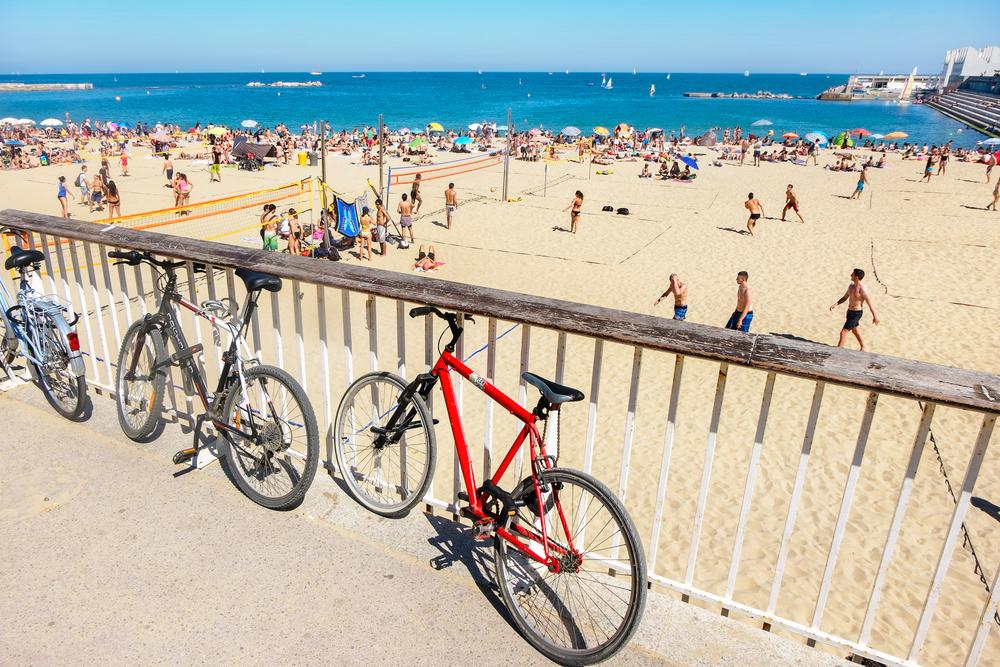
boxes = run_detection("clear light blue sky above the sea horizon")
[0,0,1000,75]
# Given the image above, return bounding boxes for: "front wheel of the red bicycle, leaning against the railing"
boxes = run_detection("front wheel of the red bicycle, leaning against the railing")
[334,373,435,518]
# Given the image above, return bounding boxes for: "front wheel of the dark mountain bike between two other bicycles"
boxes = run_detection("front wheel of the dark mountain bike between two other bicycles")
[115,320,167,441]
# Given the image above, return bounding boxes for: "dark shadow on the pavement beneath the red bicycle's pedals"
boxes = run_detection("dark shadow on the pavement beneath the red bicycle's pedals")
[425,514,517,631]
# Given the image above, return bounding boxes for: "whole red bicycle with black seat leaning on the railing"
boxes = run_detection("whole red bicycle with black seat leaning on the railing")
[334,306,646,665]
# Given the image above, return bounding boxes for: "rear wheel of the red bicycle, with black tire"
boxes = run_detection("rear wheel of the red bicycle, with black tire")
[494,468,646,665]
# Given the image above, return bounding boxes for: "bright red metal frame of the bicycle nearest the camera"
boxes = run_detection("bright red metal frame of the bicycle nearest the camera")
[431,350,576,572]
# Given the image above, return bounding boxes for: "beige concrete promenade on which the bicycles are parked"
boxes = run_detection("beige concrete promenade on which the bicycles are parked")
[0,384,846,667]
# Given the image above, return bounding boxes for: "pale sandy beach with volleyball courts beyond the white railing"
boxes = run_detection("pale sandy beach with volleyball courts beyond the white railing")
[0,138,1000,665]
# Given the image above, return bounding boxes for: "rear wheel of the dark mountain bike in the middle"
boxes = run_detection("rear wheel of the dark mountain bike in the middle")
[223,366,319,510]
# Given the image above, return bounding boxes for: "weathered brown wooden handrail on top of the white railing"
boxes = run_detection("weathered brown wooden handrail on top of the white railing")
[0,210,1000,412]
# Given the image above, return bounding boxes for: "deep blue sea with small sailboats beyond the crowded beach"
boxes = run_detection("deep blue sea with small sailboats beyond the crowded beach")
[0,71,983,146]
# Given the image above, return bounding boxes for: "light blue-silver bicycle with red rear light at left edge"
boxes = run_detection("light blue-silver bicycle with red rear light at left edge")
[0,228,87,419]
